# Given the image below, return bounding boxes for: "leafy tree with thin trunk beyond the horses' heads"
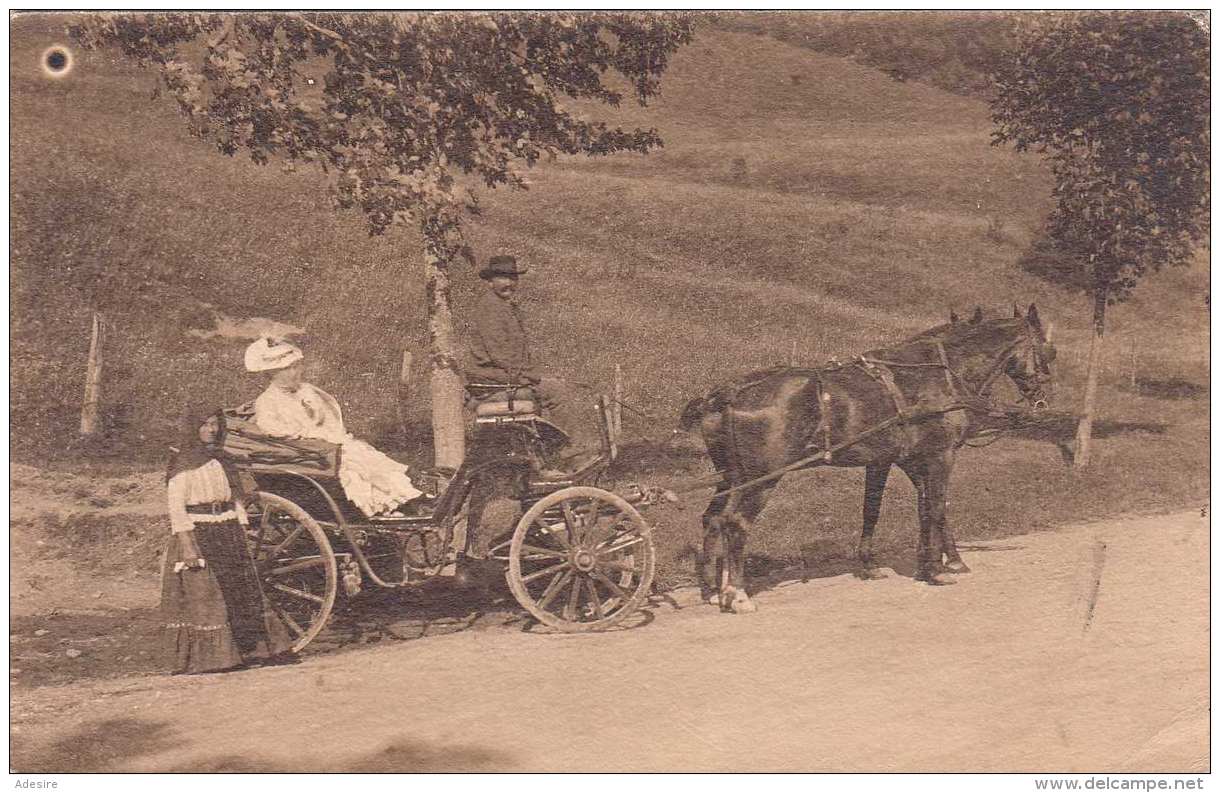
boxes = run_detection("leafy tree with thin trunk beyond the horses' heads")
[992,11,1211,467]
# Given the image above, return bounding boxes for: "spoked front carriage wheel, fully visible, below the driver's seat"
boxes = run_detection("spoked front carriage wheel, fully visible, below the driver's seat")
[508,487,656,633]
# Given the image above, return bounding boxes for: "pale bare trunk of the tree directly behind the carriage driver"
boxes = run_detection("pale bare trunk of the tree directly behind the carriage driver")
[423,240,466,468]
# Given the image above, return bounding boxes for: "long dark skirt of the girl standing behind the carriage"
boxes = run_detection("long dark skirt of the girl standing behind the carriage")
[161,520,292,673]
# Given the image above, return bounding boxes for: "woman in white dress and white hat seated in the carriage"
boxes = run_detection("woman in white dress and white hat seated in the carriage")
[245,338,423,517]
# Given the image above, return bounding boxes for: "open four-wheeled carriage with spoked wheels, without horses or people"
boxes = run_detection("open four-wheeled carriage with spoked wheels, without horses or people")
[214,384,659,651]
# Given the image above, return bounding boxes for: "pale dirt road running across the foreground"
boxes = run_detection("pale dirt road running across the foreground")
[12,510,1209,772]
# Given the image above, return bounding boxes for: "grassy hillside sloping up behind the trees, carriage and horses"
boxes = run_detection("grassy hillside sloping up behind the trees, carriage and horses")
[10,15,1208,580]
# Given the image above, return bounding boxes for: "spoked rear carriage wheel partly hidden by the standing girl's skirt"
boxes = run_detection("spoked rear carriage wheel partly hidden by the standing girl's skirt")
[246,492,339,653]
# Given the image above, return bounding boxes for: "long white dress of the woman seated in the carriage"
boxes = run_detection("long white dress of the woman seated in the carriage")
[254,383,422,516]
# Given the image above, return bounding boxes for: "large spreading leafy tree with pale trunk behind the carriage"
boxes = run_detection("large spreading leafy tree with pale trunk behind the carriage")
[72,12,693,466]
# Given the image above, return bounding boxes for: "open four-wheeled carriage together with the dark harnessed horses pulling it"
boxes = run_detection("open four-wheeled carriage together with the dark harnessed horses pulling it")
[202,305,1054,650]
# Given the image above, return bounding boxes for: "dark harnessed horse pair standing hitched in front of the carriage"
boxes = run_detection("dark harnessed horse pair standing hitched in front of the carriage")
[681,305,1054,612]
